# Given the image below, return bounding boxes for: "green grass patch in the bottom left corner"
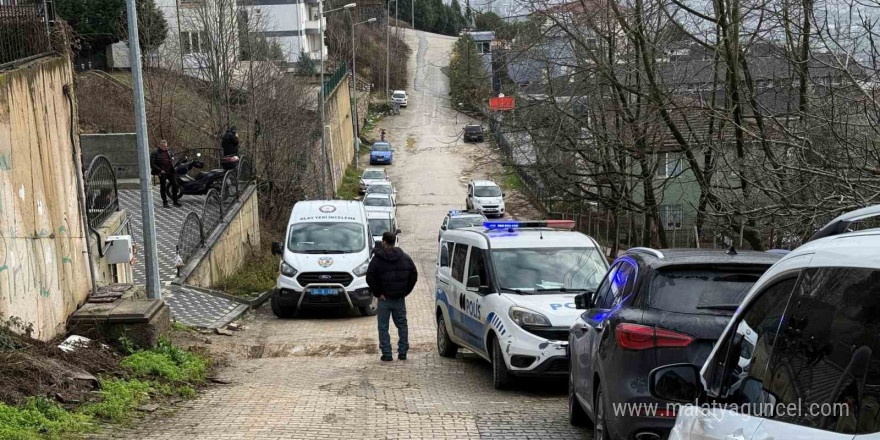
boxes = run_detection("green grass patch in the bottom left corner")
[0,397,96,440]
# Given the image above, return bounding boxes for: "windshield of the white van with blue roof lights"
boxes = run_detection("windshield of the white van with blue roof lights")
[492,248,607,294]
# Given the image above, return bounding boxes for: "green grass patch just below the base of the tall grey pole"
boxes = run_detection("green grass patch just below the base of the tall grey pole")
[120,340,209,384]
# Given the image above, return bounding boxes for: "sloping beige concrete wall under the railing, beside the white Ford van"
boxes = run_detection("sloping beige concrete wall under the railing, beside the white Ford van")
[182,186,260,288]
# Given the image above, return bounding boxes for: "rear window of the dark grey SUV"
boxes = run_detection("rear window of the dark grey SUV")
[648,269,763,315]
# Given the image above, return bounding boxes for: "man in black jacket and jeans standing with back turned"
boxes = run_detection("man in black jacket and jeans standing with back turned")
[367,231,419,362]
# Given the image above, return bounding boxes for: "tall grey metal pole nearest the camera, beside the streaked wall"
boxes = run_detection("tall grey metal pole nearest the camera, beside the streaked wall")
[122,0,162,299]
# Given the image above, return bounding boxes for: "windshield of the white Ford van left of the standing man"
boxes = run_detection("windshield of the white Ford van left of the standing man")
[287,223,366,254]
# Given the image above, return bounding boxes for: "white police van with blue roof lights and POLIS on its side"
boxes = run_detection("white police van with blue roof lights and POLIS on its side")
[436,220,608,389]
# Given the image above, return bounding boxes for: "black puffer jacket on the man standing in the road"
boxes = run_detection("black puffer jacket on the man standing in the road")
[367,247,419,298]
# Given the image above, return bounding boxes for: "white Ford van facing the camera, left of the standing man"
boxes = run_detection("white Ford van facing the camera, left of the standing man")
[272,200,377,318]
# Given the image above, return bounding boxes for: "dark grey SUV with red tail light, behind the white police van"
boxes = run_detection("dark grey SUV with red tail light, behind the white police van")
[568,248,780,440]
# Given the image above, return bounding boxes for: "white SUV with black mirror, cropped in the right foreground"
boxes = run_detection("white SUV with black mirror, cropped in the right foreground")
[649,206,880,440]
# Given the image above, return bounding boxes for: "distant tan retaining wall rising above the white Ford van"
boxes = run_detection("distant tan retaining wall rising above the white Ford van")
[324,75,354,192]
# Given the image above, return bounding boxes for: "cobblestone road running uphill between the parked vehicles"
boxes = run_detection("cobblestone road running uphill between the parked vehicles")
[104,32,589,440]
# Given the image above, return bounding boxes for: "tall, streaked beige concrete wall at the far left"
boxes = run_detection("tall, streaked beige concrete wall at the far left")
[0,57,90,339]
